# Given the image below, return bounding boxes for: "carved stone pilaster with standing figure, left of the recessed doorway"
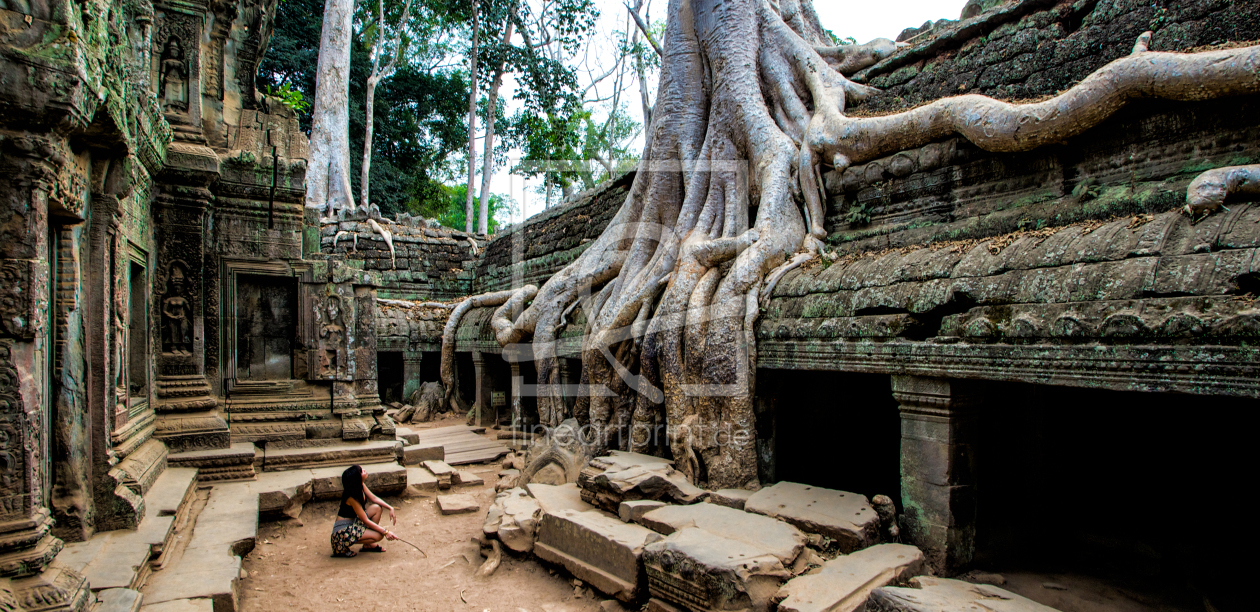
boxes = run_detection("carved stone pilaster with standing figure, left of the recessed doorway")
[152,141,229,452]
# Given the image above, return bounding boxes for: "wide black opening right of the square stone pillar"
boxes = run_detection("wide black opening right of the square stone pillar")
[975,384,1256,611]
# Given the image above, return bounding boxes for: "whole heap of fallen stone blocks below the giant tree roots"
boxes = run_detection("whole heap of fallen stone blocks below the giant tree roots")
[473,451,1051,612]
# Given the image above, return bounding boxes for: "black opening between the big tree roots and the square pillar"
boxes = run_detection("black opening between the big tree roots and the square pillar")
[757,370,901,507]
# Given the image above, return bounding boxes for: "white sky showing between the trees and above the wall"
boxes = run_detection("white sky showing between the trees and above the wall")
[478,0,966,223]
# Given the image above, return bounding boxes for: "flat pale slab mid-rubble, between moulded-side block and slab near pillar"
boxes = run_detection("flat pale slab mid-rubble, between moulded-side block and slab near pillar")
[639,504,805,567]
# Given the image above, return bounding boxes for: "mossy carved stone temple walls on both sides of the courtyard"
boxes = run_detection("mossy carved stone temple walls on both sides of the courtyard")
[0,0,1260,612]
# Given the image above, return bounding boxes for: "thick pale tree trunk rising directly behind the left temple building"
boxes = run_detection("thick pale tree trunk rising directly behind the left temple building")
[306,0,354,217]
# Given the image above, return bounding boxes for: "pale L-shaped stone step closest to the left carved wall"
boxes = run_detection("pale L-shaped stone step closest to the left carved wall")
[57,467,197,592]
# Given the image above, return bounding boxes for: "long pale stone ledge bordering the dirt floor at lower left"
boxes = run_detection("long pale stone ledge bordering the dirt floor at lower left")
[142,482,258,612]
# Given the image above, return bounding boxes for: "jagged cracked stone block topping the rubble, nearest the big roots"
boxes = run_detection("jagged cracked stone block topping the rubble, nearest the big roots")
[577,451,708,513]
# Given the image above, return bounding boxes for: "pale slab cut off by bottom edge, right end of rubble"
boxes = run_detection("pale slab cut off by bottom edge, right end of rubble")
[871,575,1057,612]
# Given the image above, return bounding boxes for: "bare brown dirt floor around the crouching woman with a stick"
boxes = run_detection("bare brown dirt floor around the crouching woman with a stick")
[241,419,604,612]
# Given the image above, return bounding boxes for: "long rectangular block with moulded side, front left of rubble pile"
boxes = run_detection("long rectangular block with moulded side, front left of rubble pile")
[534,510,660,602]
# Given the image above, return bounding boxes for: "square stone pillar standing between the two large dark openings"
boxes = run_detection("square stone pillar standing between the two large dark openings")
[892,377,979,575]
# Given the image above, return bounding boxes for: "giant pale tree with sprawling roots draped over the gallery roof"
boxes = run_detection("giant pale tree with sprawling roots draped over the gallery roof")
[442,0,1260,489]
